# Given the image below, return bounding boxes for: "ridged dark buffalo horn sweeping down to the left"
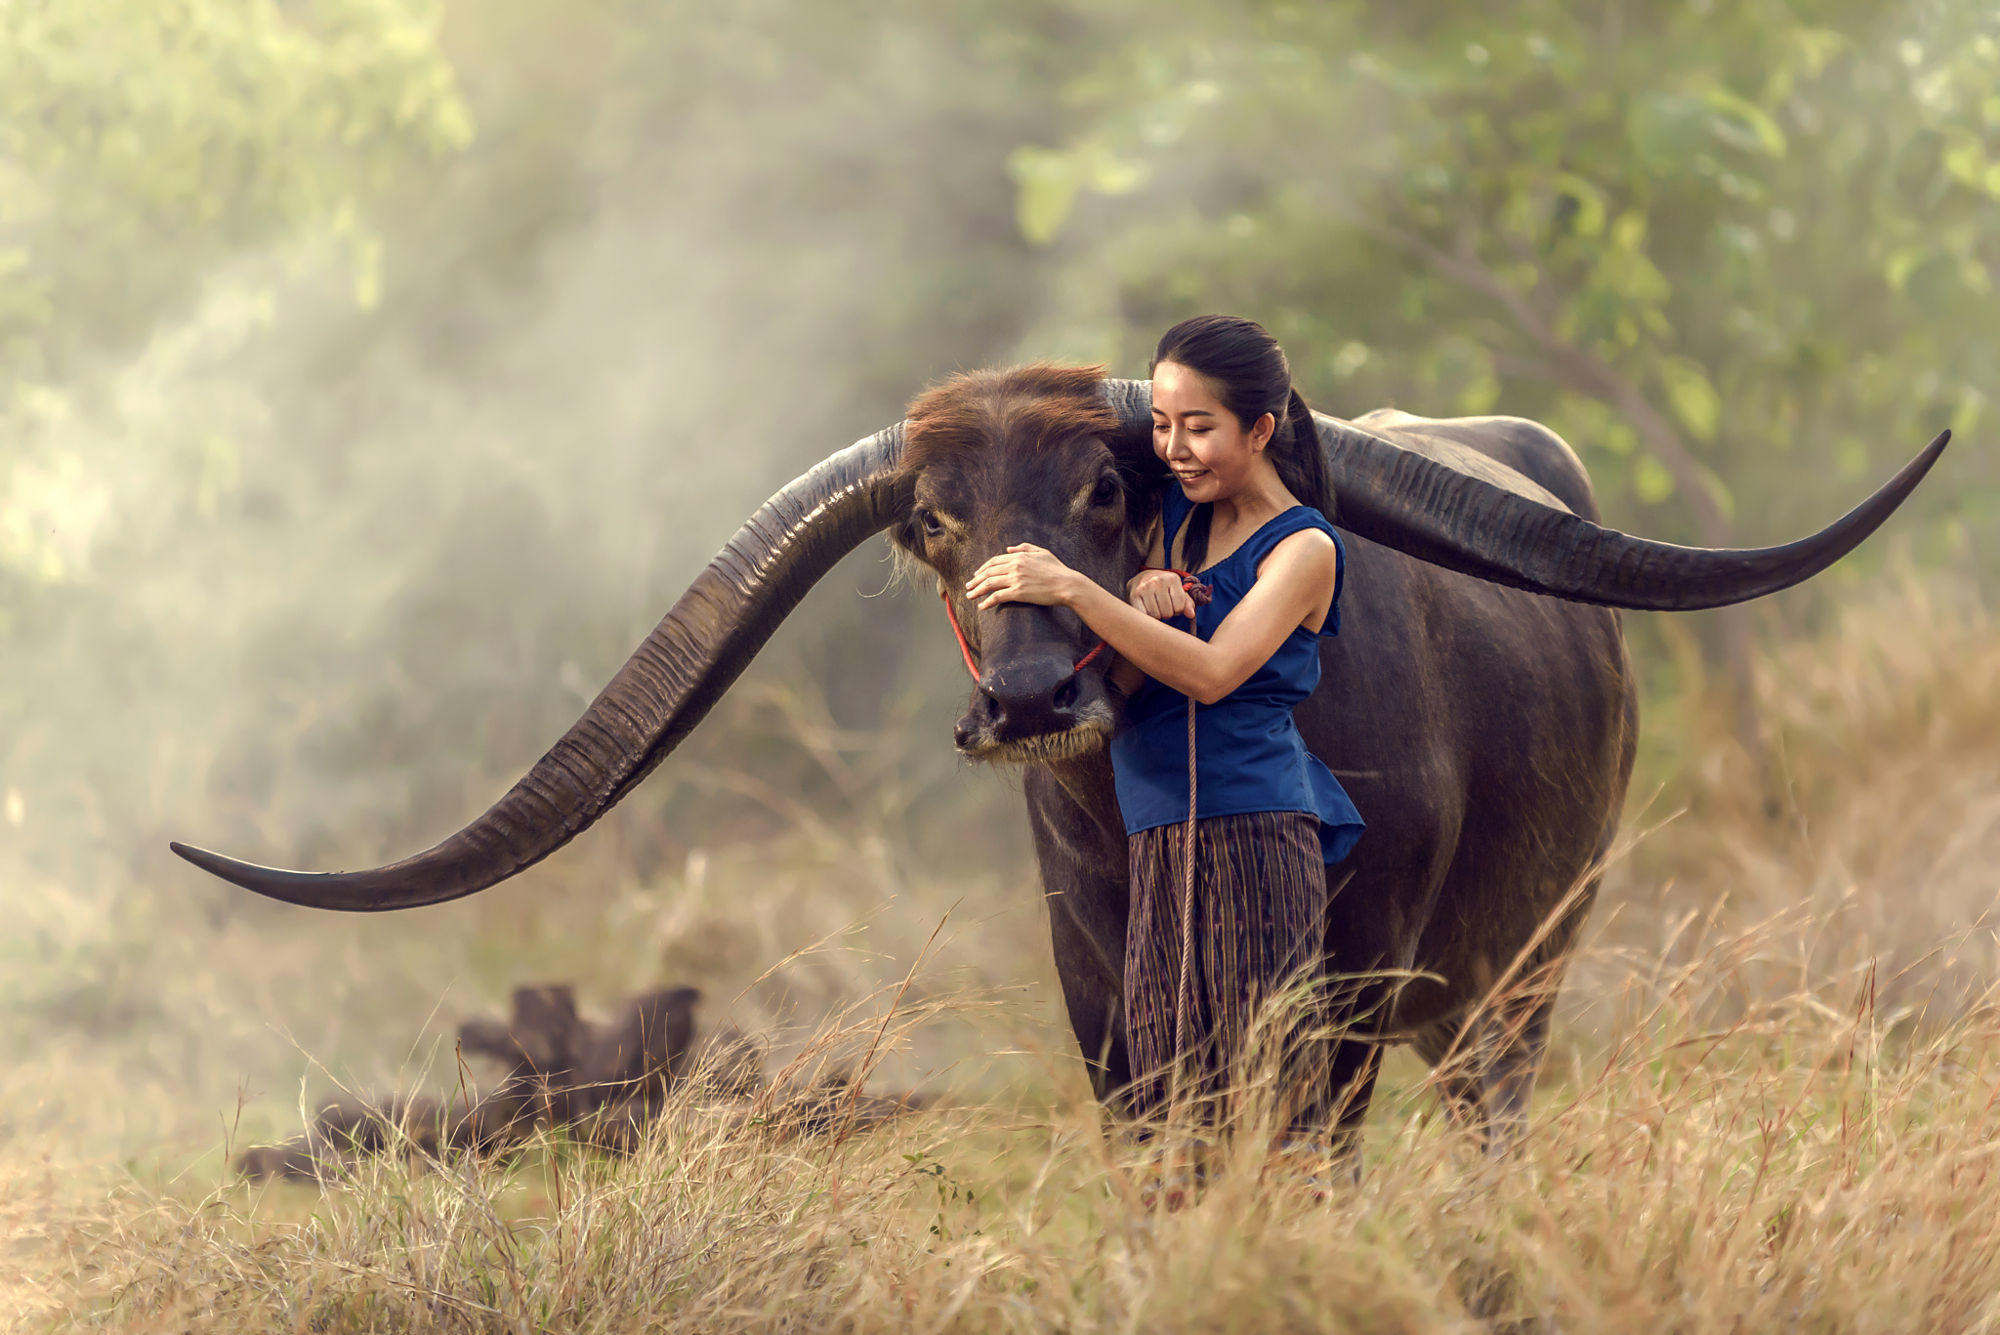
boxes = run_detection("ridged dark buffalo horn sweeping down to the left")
[172,433,910,911]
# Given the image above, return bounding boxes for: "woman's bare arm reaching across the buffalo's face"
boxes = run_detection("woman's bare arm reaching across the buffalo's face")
[966,530,1340,705]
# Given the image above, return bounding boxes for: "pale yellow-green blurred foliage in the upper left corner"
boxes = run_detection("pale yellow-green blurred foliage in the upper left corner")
[0,0,472,583]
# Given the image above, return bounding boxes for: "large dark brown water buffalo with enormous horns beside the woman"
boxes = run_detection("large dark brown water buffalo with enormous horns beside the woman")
[174,366,1946,1159]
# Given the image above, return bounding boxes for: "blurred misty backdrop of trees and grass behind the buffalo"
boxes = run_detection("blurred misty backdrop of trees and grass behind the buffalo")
[0,0,2000,1163]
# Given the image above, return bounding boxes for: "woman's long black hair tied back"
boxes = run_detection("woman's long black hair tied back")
[1146,316,1334,570]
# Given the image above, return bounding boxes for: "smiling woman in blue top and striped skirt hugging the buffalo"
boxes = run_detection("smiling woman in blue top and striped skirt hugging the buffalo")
[966,316,1362,1139]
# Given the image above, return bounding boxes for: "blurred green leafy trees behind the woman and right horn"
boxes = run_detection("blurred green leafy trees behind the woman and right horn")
[1014,0,2000,745]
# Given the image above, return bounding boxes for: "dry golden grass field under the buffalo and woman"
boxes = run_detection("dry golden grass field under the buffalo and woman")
[0,582,2000,1331]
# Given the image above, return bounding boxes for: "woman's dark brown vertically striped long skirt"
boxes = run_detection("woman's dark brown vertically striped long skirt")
[1124,811,1328,1135]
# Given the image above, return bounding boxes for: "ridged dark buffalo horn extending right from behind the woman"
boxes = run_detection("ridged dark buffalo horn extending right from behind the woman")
[1112,382,1952,612]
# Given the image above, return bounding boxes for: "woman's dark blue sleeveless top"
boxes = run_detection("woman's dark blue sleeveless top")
[1112,482,1362,861]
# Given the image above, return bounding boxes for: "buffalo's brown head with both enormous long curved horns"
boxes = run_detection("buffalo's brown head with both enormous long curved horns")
[174,366,1946,911]
